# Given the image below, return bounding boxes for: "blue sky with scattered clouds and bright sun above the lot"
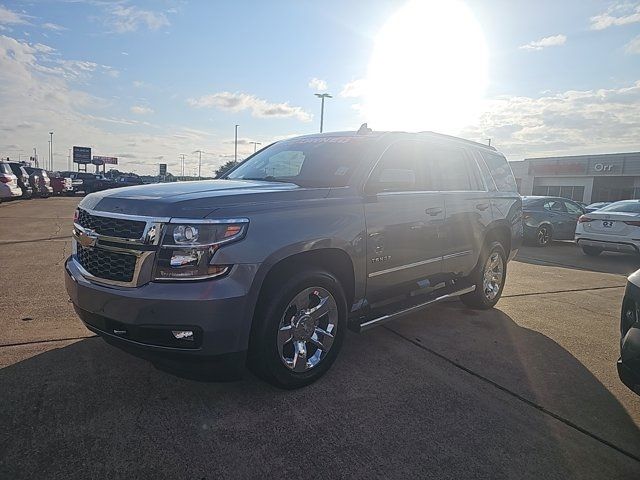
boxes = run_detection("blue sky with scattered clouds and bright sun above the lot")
[0,0,640,175]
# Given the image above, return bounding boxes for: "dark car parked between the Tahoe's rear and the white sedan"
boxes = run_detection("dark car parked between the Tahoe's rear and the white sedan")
[522,196,585,247]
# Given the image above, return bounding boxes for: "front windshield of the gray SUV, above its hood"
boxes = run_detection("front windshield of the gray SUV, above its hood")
[222,136,366,187]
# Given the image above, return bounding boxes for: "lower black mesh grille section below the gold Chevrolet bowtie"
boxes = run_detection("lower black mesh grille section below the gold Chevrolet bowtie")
[77,244,136,282]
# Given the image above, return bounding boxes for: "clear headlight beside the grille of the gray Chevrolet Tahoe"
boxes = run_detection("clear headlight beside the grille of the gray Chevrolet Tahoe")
[154,219,249,280]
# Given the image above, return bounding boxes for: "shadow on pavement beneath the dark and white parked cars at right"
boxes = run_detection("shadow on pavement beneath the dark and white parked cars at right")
[516,242,640,276]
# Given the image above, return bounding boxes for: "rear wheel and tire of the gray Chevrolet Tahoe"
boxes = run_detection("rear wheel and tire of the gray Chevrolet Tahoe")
[460,242,507,310]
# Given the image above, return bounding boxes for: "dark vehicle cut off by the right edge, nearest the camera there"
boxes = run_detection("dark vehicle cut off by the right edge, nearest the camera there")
[617,270,640,395]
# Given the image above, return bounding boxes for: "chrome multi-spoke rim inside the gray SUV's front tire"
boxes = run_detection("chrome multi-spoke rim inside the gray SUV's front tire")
[277,287,338,372]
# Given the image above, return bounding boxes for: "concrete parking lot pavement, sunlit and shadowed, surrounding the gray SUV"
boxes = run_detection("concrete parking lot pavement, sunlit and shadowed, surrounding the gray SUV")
[0,198,640,480]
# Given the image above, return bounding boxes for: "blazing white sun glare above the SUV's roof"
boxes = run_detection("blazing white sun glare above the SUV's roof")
[364,0,488,134]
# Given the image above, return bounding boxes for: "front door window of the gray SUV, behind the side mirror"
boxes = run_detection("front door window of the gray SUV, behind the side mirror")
[367,142,432,192]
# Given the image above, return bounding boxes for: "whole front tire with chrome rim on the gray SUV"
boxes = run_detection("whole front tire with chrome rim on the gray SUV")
[248,270,347,389]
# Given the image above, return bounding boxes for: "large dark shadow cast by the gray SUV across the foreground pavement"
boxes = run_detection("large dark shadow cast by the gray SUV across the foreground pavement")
[0,316,640,479]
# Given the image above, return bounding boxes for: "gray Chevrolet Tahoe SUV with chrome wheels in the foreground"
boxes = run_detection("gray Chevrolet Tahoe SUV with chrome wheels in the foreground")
[65,129,522,388]
